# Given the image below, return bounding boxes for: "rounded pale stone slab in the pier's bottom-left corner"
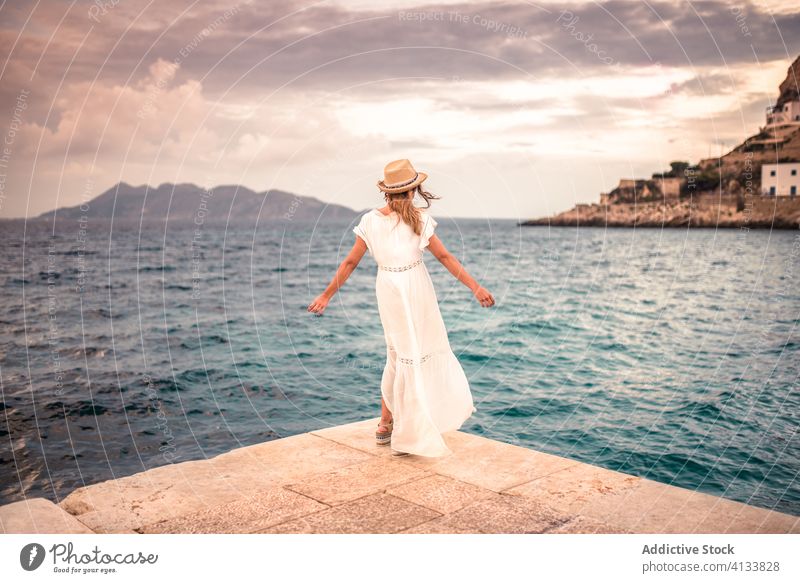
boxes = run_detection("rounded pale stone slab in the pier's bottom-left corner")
[0,498,92,534]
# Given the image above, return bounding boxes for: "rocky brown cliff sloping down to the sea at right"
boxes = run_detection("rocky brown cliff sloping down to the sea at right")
[520,57,800,229]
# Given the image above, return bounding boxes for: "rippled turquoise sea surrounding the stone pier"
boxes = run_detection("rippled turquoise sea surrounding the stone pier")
[0,217,800,514]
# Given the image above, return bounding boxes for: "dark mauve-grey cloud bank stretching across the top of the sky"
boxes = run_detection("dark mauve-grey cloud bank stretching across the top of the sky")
[2,0,800,101]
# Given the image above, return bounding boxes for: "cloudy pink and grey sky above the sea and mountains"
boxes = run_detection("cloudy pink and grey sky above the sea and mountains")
[0,0,800,219]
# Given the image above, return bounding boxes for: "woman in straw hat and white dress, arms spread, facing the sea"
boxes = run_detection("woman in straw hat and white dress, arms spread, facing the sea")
[308,160,494,457]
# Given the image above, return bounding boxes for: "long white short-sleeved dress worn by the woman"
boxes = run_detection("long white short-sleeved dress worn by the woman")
[353,209,476,457]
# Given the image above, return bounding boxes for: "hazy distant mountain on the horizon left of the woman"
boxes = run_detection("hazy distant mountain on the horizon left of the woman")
[31,182,357,223]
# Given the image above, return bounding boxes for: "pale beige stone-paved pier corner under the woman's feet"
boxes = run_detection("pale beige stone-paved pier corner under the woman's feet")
[0,417,800,534]
